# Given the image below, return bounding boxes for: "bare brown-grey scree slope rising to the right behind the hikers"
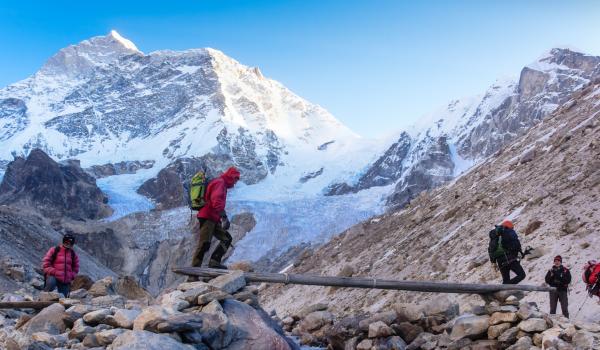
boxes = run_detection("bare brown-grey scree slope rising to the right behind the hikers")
[262,81,600,321]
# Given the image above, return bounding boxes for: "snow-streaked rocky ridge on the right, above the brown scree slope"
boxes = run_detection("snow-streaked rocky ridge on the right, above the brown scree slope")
[327,48,600,207]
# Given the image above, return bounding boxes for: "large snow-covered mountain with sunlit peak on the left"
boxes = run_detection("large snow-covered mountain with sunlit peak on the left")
[0,31,376,194]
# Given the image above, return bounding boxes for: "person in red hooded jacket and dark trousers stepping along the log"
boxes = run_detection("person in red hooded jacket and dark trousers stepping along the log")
[191,167,240,272]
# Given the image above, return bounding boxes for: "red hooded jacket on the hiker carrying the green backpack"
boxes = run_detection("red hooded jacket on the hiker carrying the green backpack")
[198,167,240,222]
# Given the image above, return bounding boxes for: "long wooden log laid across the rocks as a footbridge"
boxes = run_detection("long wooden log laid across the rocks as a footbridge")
[173,267,555,294]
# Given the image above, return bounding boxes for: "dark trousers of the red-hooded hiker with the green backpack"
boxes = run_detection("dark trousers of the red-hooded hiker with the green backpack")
[192,219,233,267]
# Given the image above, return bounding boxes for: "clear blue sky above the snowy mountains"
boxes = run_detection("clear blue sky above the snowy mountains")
[0,0,600,136]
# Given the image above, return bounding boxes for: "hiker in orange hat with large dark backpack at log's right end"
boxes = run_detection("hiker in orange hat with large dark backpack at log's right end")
[488,220,525,284]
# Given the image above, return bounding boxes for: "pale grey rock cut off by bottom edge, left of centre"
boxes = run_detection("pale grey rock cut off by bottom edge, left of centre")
[107,330,195,350]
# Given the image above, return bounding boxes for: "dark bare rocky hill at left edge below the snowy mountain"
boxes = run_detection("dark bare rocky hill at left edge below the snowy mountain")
[0,149,112,220]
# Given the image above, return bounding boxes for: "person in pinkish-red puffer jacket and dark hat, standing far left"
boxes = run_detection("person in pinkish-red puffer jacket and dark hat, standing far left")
[42,233,79,297]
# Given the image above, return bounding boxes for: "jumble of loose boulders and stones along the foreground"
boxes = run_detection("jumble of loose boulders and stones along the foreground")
[0,271,600,350]
